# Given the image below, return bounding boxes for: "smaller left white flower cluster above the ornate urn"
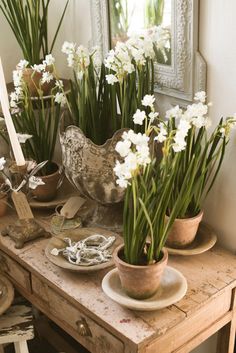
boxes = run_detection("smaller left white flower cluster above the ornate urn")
[61,42,100,80]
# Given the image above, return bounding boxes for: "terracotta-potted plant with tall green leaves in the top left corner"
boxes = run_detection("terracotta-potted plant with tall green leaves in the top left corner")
[0,0,69,96]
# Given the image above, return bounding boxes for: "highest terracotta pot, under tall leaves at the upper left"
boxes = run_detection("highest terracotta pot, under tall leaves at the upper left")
[23,67,55,97]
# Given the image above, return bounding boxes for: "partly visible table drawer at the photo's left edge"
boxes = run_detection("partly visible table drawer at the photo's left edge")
[0,251,31,293]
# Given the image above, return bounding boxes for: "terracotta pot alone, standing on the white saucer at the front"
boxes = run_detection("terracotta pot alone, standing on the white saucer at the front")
[113,245,168,299]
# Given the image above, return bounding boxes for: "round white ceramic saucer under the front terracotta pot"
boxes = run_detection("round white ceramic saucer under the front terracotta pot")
[102,266,187,311]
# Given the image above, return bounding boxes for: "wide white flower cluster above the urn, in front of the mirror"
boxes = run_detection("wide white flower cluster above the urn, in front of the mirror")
[105,26,169,85]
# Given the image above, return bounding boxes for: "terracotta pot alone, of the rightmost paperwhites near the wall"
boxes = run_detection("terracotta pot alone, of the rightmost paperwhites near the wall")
[166,211,203,249]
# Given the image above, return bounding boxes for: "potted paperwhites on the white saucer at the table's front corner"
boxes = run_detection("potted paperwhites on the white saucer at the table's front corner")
[114,95,192,299]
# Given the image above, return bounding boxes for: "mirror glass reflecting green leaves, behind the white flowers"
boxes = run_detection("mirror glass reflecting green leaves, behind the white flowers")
[108,0,172,65]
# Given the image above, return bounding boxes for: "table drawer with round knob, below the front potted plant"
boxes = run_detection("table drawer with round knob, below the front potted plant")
[48,288,124,353]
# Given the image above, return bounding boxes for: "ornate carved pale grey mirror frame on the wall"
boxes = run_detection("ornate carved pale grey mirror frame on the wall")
[90,0,206,105]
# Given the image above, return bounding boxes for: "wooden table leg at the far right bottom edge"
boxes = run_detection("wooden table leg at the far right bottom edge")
[217,288,236,353]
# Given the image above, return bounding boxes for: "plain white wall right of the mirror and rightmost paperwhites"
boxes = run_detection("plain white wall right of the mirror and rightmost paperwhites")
[200,0,236,252]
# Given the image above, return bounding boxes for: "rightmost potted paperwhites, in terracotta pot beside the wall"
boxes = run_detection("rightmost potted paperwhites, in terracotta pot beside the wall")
[159,92,236,248]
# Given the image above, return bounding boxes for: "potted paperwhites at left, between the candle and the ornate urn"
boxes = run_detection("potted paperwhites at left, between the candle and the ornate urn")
[10,54,64,201]
